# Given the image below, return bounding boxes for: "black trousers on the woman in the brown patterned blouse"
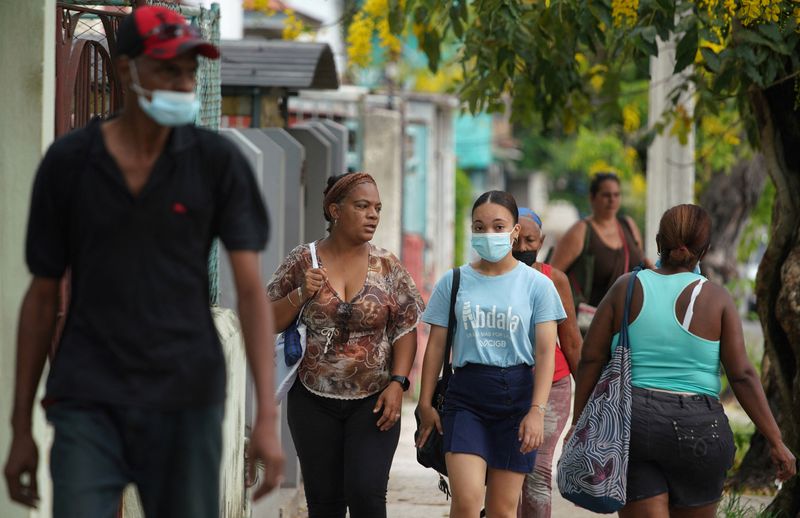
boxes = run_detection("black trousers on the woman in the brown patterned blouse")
[288,381,400,518]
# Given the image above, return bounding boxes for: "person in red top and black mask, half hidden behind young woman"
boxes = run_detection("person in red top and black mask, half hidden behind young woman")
[511,208,583,518]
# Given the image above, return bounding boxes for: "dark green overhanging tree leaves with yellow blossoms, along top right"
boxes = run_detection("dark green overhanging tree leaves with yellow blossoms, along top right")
[390,0,800,144]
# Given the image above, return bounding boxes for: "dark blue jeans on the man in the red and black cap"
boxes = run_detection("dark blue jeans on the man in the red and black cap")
[47,401,224,518]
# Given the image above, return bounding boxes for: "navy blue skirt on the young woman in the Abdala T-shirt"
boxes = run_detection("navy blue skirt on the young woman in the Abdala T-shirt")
[442,364,536,473]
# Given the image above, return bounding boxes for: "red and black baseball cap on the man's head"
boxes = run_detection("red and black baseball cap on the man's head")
[117,5,219,59]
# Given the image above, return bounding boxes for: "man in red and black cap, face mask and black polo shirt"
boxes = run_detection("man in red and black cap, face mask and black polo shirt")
[5,7,283,518]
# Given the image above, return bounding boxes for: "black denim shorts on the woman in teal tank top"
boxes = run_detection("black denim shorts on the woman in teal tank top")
[627,387,736,507]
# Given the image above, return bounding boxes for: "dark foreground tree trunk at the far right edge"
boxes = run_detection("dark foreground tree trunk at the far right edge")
[750,80,800,516]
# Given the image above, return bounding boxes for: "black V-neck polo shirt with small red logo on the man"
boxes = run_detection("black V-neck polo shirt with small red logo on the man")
[26,120,268,409]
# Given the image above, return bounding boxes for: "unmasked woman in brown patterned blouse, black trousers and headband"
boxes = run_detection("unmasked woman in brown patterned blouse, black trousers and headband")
[267,173,423,518]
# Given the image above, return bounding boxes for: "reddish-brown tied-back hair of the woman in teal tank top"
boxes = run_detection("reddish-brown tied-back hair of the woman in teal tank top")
[656,204,711,267]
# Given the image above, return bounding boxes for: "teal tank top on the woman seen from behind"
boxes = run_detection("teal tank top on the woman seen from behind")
[611,270,720,398]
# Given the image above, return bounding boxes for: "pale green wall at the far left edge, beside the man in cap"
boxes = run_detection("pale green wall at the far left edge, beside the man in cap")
[0,0,55,518]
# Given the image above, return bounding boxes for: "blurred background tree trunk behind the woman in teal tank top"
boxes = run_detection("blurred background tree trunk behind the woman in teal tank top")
[700,153,767,284]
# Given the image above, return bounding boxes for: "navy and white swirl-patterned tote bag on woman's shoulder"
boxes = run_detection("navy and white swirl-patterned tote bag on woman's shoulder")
[557,268,639,513]
